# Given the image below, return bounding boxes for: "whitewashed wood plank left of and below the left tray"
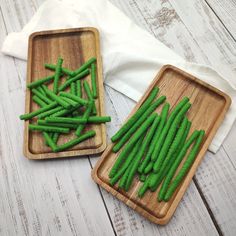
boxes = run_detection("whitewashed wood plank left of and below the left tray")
[0,9,114,236]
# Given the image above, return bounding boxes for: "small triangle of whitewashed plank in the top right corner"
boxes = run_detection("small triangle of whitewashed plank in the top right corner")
[206,0,236,40]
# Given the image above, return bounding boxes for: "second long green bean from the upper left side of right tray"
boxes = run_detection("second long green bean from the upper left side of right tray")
[112,96,166,152]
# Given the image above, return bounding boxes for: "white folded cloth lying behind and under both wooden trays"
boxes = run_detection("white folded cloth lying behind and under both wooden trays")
[2,0,236,152]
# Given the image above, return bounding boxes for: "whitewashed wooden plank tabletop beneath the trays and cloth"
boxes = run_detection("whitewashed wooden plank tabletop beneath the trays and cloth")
[0,0,236,236]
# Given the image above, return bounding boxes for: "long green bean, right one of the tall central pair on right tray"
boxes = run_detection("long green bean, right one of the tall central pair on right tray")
[153,103,191,173]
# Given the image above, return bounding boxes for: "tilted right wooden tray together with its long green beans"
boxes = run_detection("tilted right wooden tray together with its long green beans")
[92,66,230,224]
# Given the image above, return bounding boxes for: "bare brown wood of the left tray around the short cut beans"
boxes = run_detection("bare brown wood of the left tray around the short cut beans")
[24,28,106,159]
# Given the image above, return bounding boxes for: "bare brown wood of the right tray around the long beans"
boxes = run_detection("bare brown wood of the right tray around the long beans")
[92,65,231,225]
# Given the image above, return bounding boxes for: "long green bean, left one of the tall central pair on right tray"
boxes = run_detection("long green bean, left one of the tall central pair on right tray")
[151,97,189,161]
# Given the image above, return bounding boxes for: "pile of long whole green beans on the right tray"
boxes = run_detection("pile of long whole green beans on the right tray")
[109,87,205,201]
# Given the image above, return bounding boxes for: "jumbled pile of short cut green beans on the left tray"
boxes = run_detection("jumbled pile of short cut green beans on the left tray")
[20,57,111,152]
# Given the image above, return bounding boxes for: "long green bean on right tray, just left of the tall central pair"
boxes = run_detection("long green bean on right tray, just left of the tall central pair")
[138,103,170,174]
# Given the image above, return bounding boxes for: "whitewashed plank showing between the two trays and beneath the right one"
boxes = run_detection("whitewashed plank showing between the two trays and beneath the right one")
[91,86,218,236]
